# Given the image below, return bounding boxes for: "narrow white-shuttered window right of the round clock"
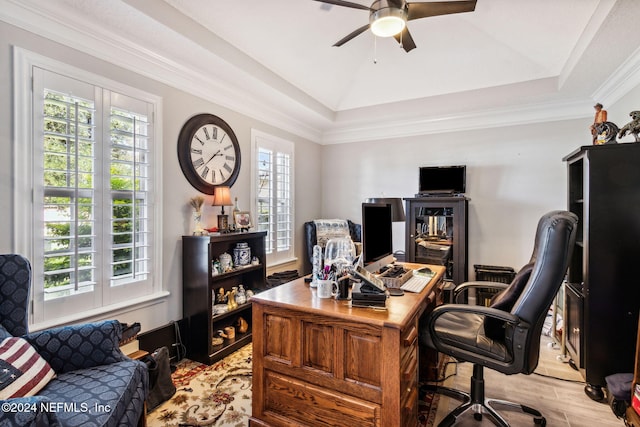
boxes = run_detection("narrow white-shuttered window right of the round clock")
[251,130,294,265]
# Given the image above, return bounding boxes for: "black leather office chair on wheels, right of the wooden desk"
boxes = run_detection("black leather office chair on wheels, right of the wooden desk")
[420,211,578,427]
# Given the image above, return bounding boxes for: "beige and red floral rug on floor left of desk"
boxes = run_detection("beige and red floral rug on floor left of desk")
[147,344,252,427]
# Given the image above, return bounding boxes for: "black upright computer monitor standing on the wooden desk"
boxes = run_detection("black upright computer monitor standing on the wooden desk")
[362,203,394,273]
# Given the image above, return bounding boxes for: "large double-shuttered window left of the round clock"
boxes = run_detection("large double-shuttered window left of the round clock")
[15,51,161,323]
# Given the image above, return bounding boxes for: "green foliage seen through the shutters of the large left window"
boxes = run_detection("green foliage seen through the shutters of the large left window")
[43,92,146,289]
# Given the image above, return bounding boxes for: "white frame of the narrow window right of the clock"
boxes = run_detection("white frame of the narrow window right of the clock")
[251,129,297,267]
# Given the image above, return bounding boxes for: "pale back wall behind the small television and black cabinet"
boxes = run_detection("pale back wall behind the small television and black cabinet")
[322,120,591,279]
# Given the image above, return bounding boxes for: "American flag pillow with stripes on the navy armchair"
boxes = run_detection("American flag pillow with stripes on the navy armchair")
[0,337,55,399]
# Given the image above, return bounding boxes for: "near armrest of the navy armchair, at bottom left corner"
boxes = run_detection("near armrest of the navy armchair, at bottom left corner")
[0,396,61,427]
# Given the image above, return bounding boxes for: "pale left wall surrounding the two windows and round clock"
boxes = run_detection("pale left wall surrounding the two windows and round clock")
[0,22,322,330]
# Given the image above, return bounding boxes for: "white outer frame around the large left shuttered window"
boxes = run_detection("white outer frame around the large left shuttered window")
[13,47,168,329]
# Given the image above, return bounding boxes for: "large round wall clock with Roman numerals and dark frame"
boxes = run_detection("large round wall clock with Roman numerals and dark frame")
[178,114,240,194]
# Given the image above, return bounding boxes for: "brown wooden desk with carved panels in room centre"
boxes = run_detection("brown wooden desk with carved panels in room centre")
[249,264,444,427]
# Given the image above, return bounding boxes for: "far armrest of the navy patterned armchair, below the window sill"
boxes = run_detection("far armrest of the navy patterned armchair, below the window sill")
[24,320,127,374]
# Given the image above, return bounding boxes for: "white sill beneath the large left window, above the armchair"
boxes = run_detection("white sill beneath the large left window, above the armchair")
[29,291,171,332]
